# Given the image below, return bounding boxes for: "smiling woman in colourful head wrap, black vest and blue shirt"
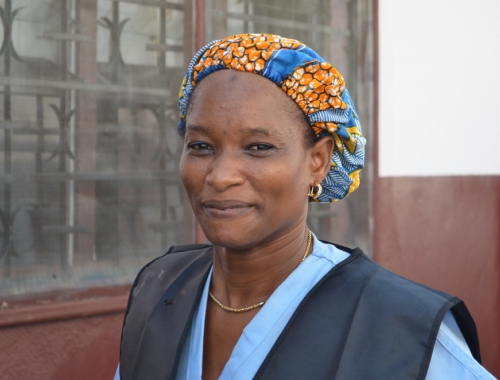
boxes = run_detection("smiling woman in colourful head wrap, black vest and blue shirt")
[116,34,492,380]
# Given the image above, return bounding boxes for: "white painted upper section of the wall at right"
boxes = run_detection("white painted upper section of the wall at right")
[379,0,500,177]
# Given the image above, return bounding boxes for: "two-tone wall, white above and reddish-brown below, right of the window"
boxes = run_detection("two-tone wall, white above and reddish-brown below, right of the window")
[374,0,500,377]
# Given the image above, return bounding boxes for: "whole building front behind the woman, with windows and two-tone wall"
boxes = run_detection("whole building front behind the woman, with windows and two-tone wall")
[0,0,500,379]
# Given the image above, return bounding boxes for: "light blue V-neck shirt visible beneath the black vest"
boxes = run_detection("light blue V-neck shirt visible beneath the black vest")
[115,237,494,380]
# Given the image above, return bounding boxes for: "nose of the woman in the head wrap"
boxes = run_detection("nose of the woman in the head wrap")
[205,153,245,192]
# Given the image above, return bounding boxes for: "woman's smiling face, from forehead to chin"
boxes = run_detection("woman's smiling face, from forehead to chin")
[180,70,315,250]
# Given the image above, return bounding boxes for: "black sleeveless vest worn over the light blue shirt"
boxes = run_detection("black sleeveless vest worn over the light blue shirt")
[120,245,480,380]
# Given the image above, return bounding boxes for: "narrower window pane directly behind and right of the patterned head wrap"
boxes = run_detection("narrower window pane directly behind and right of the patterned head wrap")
[206,0,373,252]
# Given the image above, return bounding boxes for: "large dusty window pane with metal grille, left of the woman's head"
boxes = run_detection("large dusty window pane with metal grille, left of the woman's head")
[0,0,192,295]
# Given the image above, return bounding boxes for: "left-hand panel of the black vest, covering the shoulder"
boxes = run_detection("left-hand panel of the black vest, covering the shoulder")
[120,245,212,379]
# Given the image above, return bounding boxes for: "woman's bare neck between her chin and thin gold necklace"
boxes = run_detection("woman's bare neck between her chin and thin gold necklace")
[211,223,308,308]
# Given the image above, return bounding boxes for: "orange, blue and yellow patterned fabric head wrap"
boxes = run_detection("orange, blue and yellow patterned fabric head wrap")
[179,34,366,202]
